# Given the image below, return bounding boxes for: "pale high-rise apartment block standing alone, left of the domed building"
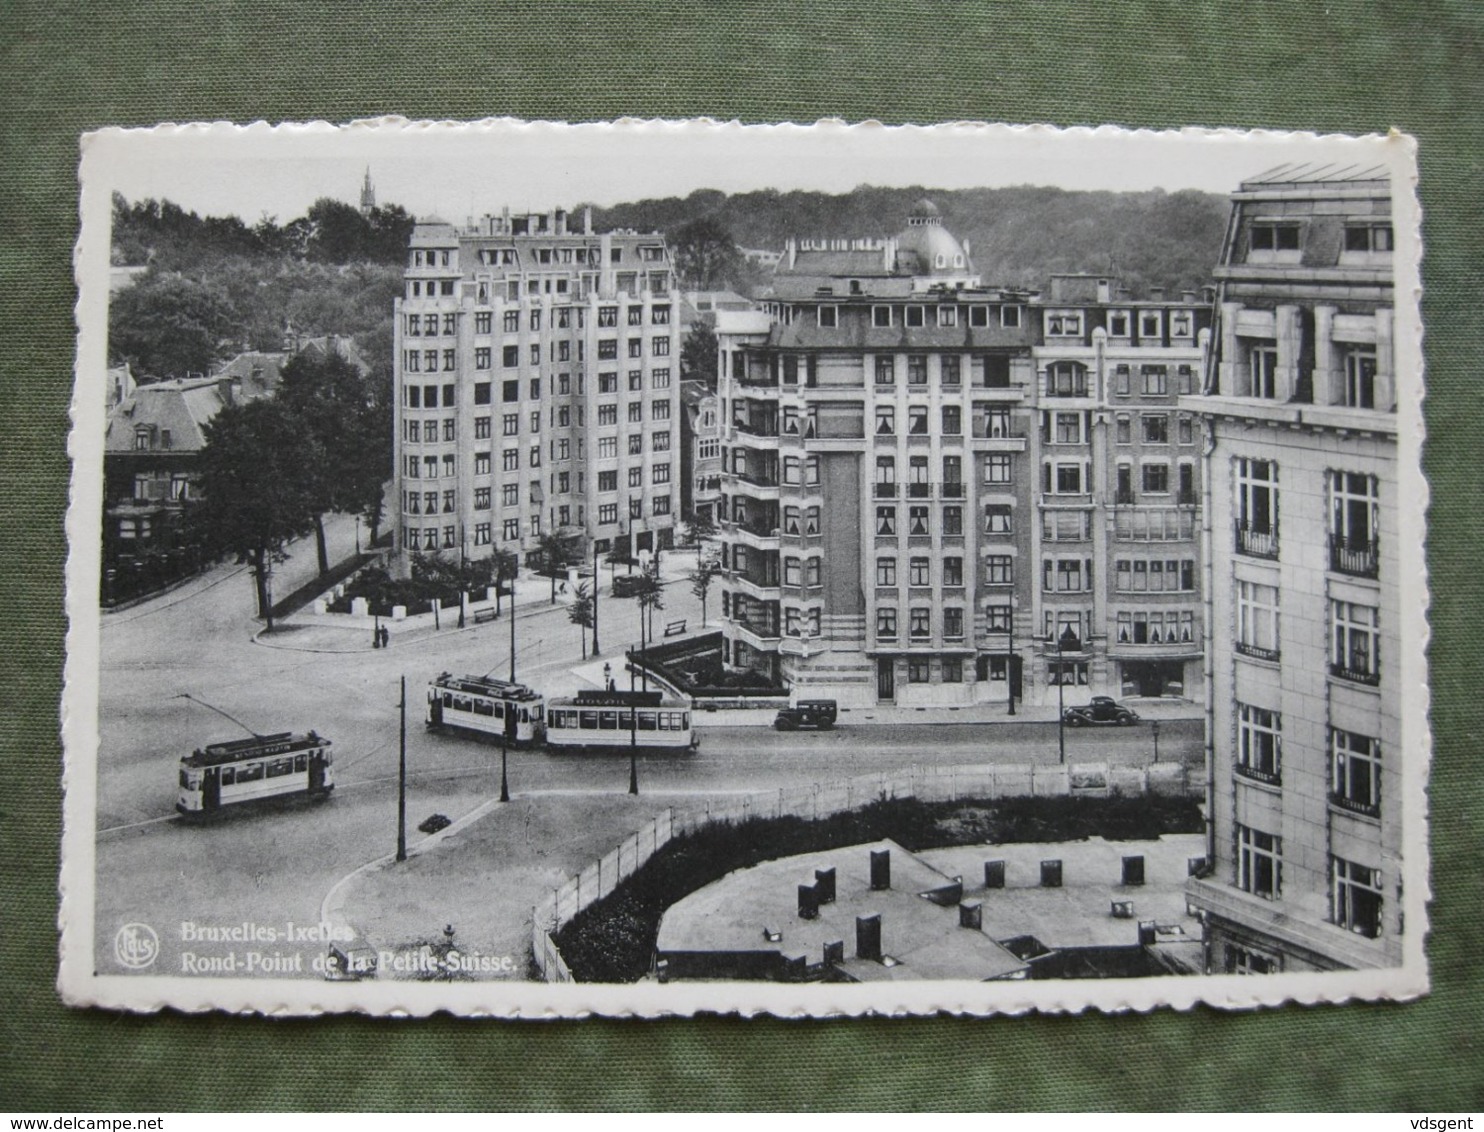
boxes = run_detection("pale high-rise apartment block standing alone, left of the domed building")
[393,211,681,567]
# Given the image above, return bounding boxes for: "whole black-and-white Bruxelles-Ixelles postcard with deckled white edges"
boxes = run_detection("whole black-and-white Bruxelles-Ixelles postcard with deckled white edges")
[59,120,1431,1018]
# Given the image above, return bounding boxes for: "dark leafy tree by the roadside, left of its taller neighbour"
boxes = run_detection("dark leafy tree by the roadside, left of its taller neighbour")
[194,401,324,632]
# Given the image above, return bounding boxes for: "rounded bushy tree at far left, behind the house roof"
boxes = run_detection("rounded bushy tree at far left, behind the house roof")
[108,272,239,378]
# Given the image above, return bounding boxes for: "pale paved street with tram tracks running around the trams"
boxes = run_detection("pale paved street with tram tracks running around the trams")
[95,516,1202,973]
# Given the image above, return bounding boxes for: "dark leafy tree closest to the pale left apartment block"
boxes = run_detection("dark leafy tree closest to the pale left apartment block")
[278,352,392,574]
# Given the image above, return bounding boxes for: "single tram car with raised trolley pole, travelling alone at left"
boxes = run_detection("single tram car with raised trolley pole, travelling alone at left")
[175,731,335,817]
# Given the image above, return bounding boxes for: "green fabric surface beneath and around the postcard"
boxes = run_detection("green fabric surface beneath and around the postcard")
[0,0,1484,1111]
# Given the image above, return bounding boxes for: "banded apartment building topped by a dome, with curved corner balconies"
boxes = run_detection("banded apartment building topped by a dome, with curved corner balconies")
[717,202,1034,705]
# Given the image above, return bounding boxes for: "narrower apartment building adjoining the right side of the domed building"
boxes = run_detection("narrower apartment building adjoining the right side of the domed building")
[1026,274,1211,699]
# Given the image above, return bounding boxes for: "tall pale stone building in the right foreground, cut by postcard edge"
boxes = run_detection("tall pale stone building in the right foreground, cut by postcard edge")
[1178,166,1404,973]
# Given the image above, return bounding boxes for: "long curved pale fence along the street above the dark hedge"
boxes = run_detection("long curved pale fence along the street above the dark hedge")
[531,763,1205,982]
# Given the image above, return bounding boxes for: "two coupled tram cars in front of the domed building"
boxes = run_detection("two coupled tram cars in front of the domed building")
[426,672,700,754]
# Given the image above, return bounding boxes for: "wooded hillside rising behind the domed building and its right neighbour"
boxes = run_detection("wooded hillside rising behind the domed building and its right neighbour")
[579,185,1229,295]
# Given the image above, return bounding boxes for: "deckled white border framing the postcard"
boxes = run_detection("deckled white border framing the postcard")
[58,117,1432,1019]
